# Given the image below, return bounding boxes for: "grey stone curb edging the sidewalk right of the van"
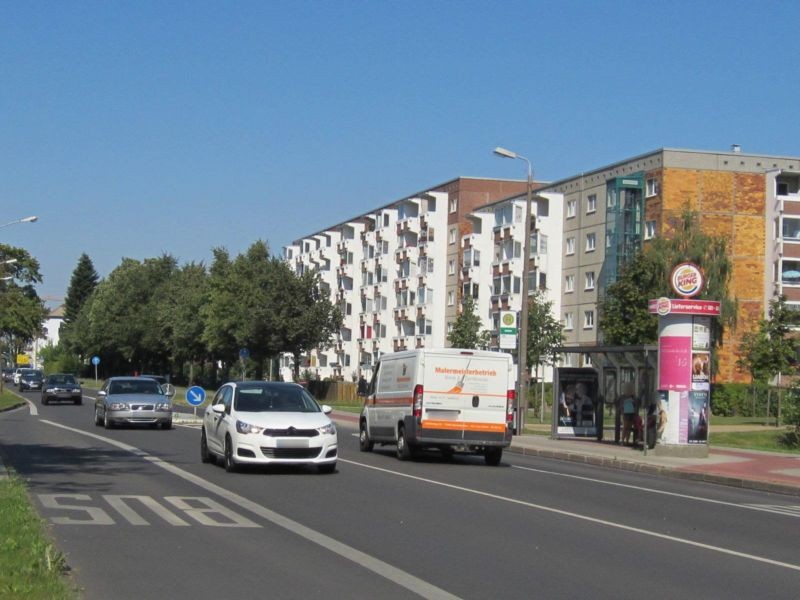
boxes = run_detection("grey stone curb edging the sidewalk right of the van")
[506,444,800,497]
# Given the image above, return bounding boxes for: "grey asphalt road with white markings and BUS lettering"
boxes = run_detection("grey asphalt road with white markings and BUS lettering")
[0,386,800,599]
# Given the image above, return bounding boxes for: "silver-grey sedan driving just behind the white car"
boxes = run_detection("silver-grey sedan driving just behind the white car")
[94,377,172,429]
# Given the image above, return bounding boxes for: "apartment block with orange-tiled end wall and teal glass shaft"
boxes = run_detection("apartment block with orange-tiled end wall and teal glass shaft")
[540,146,800,381]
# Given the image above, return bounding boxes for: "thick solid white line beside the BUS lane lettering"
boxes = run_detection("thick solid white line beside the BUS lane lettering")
[41,419,460,600]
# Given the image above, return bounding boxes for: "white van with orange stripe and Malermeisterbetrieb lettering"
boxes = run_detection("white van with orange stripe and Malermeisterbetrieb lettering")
[359,348,515,465]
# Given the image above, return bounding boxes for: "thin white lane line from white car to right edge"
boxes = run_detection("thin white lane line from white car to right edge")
[339,457,800,571]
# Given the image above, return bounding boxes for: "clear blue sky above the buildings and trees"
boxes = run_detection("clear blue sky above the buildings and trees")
[0,0,800,305]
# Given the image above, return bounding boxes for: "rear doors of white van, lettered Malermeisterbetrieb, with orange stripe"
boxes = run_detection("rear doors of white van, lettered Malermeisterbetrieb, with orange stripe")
[421,350,511,441]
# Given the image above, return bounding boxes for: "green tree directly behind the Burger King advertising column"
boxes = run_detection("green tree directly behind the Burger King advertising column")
[598,208,736,354]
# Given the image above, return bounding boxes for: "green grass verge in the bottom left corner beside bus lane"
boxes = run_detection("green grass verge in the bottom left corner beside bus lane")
[0,476,77,600]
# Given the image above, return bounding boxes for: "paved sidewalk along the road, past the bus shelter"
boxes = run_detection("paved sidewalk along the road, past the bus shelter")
[333,411,800,496]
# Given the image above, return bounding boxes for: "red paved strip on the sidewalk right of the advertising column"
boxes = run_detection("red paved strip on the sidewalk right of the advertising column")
[678,449,800,486]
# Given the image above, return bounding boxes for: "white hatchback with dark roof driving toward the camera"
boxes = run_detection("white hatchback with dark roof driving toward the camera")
[200,381,338,473]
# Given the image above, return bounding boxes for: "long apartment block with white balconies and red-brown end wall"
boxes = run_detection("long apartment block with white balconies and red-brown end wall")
[281,177,527,379]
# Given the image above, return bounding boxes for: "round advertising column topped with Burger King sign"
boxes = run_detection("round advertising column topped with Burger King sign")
[650,263,720,452]
